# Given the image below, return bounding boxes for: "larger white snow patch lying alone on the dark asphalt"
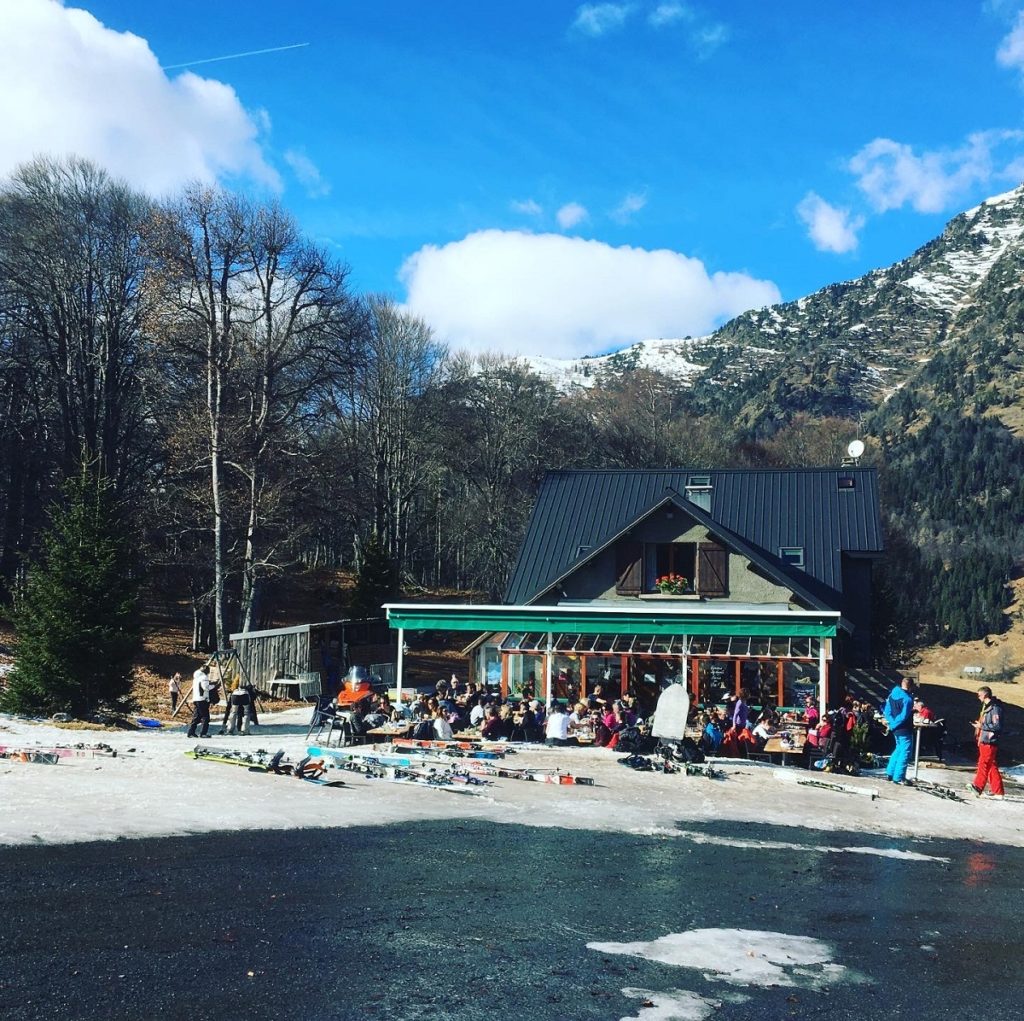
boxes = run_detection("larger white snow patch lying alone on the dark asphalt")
[587,929,863,989]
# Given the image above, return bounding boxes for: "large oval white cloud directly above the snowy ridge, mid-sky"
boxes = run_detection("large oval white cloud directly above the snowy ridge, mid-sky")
[400,230,780,357]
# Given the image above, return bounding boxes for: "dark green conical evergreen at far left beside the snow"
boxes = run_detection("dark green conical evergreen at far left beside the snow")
[0,468,141,718]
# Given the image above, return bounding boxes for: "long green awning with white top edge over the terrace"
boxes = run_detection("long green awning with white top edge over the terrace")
[384,603,840,638]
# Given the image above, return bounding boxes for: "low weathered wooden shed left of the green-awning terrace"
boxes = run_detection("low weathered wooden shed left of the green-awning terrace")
[230,618,394,696]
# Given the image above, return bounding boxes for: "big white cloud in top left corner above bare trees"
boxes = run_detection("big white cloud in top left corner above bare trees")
[0,0,281,194]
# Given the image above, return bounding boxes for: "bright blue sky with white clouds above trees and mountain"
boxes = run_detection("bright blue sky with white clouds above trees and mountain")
[0,0,1024,356]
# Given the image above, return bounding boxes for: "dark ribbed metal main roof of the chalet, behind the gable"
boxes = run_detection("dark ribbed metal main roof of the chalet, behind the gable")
[505,468,883,603]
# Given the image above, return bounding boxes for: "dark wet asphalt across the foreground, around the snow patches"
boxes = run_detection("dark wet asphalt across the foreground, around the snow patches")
[0,822,1024,1021]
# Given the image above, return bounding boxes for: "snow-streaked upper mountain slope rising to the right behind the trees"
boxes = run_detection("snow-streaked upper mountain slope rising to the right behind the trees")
[527,185,1024,424]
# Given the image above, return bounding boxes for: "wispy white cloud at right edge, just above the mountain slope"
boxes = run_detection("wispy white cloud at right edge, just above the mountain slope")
[849,131,1024,213]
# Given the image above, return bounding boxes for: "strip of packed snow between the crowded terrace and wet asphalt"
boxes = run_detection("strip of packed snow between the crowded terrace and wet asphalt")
[0,709,1024,847]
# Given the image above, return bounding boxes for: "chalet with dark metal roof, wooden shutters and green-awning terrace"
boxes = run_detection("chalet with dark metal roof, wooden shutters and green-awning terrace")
[387,467,883,706]
